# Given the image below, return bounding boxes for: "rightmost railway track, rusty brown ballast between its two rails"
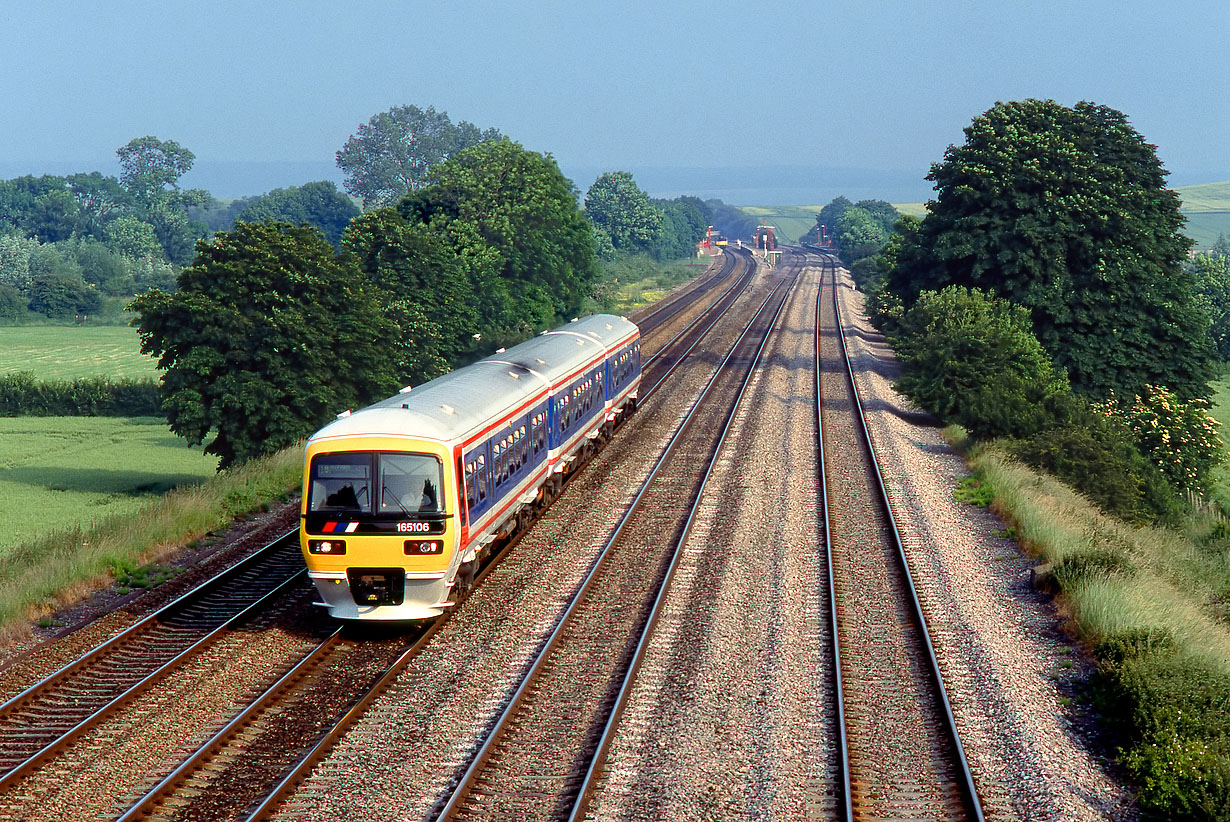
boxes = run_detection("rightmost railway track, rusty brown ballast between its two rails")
[815,256,983,821]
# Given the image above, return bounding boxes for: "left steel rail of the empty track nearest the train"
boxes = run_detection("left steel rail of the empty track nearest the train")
[435,267,792,820]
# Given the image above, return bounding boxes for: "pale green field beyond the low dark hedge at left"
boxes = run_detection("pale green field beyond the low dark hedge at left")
[0,326,159,379]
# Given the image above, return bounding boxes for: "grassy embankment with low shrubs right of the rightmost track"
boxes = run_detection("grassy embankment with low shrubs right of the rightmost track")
[947,429,1230,820]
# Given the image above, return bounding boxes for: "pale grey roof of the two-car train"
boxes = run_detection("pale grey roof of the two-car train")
[311,314,638,450]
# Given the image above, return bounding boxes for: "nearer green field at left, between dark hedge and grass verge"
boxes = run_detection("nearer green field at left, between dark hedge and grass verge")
[0,417,218,557]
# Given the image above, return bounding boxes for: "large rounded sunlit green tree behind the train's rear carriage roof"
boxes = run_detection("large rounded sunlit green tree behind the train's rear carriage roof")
[399,139,599,349]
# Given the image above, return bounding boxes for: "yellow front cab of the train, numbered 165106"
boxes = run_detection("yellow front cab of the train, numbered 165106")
[300,437,460,620]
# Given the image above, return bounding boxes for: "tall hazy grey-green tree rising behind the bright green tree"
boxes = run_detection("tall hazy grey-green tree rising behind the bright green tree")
[337,106,501,208]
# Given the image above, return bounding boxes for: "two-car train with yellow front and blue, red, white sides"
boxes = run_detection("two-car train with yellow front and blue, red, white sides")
[299,314,641,620]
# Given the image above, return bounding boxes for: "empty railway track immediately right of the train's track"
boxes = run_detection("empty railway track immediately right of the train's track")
[439,259,788,820]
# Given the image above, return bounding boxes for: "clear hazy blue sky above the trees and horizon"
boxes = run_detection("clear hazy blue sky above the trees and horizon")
[0,0,1230,204]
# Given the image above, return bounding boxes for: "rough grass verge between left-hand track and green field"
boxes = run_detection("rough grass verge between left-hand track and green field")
[0,448,303,635]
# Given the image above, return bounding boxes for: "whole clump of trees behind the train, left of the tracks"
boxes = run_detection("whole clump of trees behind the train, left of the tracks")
[132,106,728,470]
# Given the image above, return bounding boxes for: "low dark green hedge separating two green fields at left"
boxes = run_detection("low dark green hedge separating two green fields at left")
[0,372,162,417]
